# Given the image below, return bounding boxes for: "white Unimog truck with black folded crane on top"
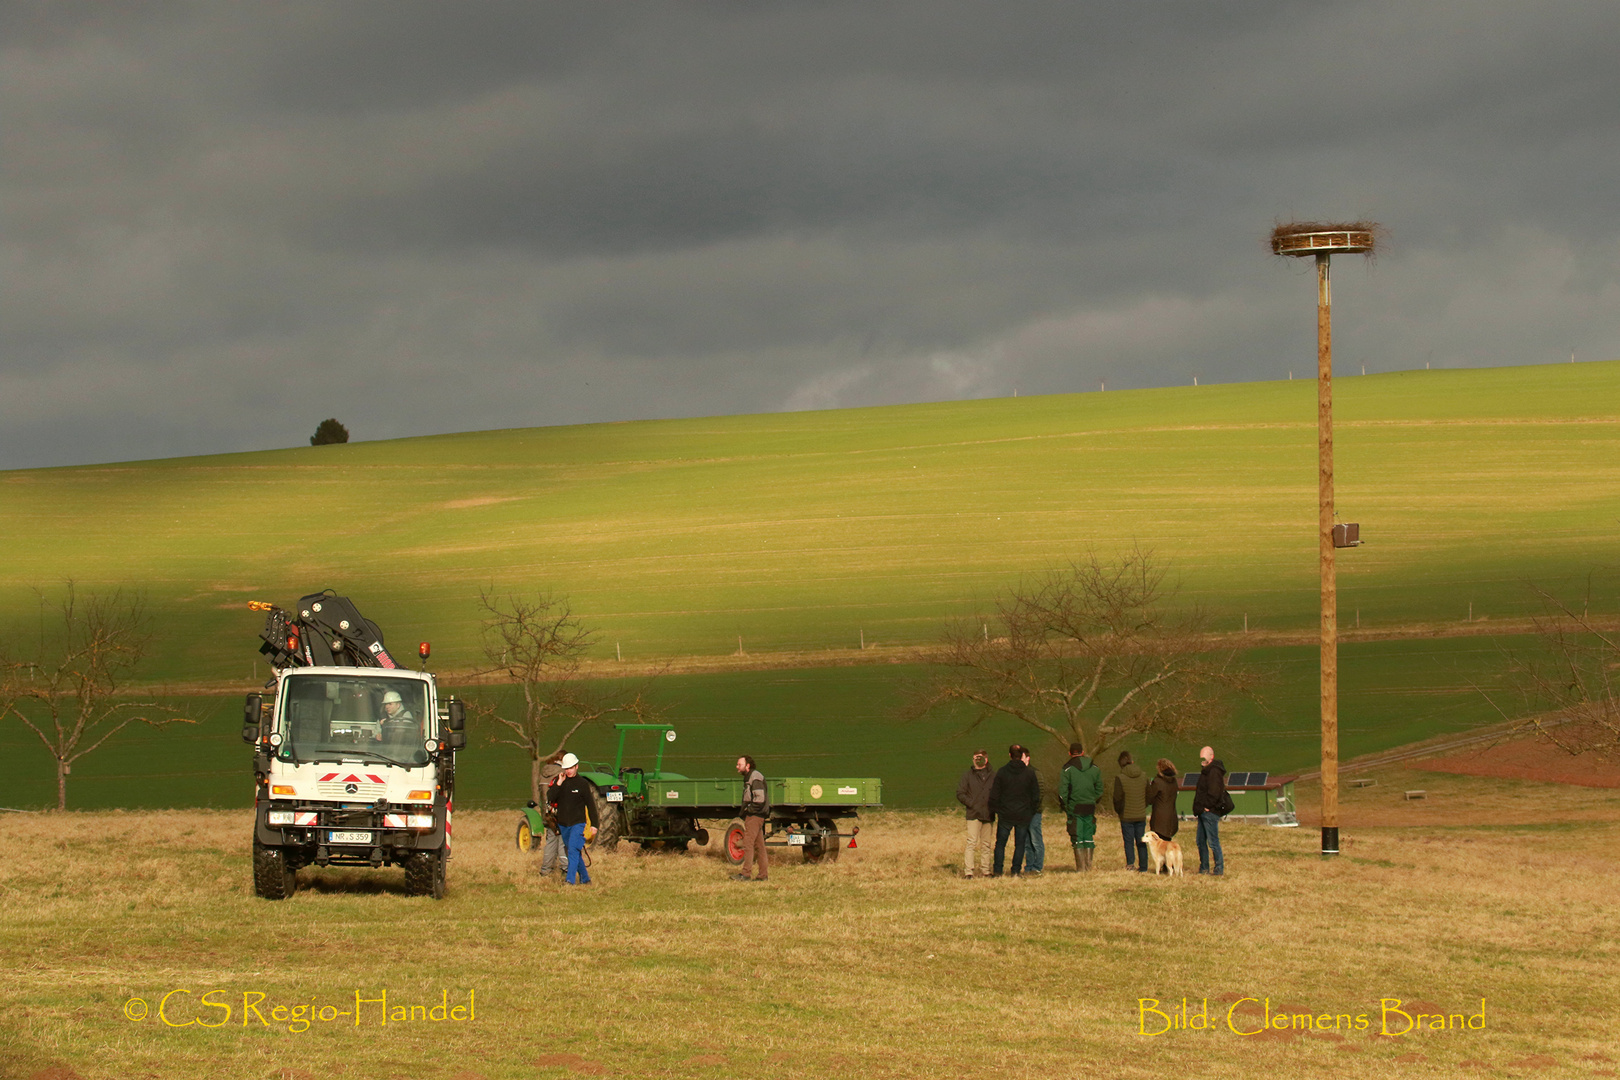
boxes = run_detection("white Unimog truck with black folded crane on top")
[241,589,467,900]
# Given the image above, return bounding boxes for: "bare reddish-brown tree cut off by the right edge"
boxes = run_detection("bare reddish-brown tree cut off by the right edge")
[1511,580,1620,755]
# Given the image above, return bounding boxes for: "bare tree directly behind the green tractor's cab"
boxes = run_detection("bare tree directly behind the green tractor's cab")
[470,588,653,801]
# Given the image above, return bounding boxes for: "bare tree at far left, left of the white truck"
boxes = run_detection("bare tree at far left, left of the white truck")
[0,581,193,810]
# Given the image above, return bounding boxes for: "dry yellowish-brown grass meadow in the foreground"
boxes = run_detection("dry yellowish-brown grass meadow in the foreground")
[0,766,1620,1080]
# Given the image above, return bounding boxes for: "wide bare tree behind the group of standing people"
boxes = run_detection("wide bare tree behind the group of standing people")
[910,547,1256,756]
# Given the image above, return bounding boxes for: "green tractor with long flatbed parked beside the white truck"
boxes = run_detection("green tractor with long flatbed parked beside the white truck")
[517,724,883,865]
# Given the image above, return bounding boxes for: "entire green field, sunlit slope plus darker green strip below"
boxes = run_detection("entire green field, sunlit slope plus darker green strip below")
[0,363,1620,806]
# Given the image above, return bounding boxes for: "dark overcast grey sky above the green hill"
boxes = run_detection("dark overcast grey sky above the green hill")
[0,0,1620,468]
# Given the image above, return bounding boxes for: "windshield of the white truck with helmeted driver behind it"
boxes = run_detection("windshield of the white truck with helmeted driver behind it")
[275,675,428,766]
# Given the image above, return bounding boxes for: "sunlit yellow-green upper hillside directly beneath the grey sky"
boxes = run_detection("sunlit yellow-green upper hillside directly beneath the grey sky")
[0,363,1620,682]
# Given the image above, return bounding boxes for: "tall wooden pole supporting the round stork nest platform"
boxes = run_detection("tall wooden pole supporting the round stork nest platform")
[1317,253,1338,855]
